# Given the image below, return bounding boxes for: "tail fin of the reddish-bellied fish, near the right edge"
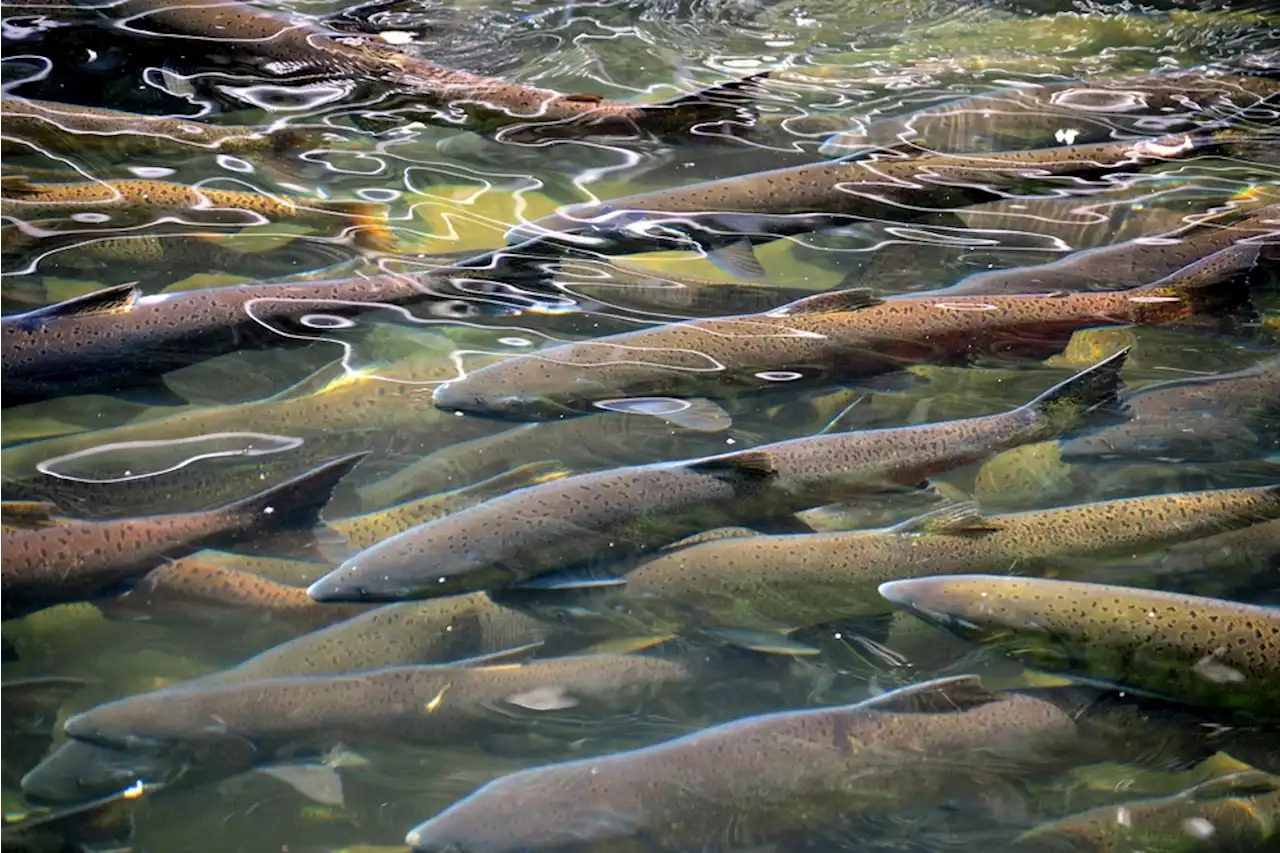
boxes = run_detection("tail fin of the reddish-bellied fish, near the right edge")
[1133,243,1261,325]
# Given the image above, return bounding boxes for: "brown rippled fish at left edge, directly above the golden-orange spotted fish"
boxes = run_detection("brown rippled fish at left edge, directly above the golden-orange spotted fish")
[0,96,307,156]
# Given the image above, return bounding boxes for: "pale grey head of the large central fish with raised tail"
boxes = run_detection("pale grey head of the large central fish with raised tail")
[307,540,518,603]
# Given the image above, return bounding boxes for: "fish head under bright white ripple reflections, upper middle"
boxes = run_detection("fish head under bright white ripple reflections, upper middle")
[506,202,698,255]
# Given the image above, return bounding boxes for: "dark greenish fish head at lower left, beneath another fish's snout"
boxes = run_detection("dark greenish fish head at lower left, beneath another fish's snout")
[22,740,186,804]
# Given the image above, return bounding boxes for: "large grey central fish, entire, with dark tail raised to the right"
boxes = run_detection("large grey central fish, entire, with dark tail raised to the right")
[310,351,1128,602]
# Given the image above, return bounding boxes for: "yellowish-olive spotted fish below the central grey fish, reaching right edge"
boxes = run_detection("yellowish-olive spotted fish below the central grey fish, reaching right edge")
[524,485,1280,633]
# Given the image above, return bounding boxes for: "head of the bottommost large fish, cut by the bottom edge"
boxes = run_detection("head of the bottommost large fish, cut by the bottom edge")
[404,762,645,853]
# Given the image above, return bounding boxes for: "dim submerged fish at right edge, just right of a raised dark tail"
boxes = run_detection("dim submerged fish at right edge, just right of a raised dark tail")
[1059,350,1280,465]
